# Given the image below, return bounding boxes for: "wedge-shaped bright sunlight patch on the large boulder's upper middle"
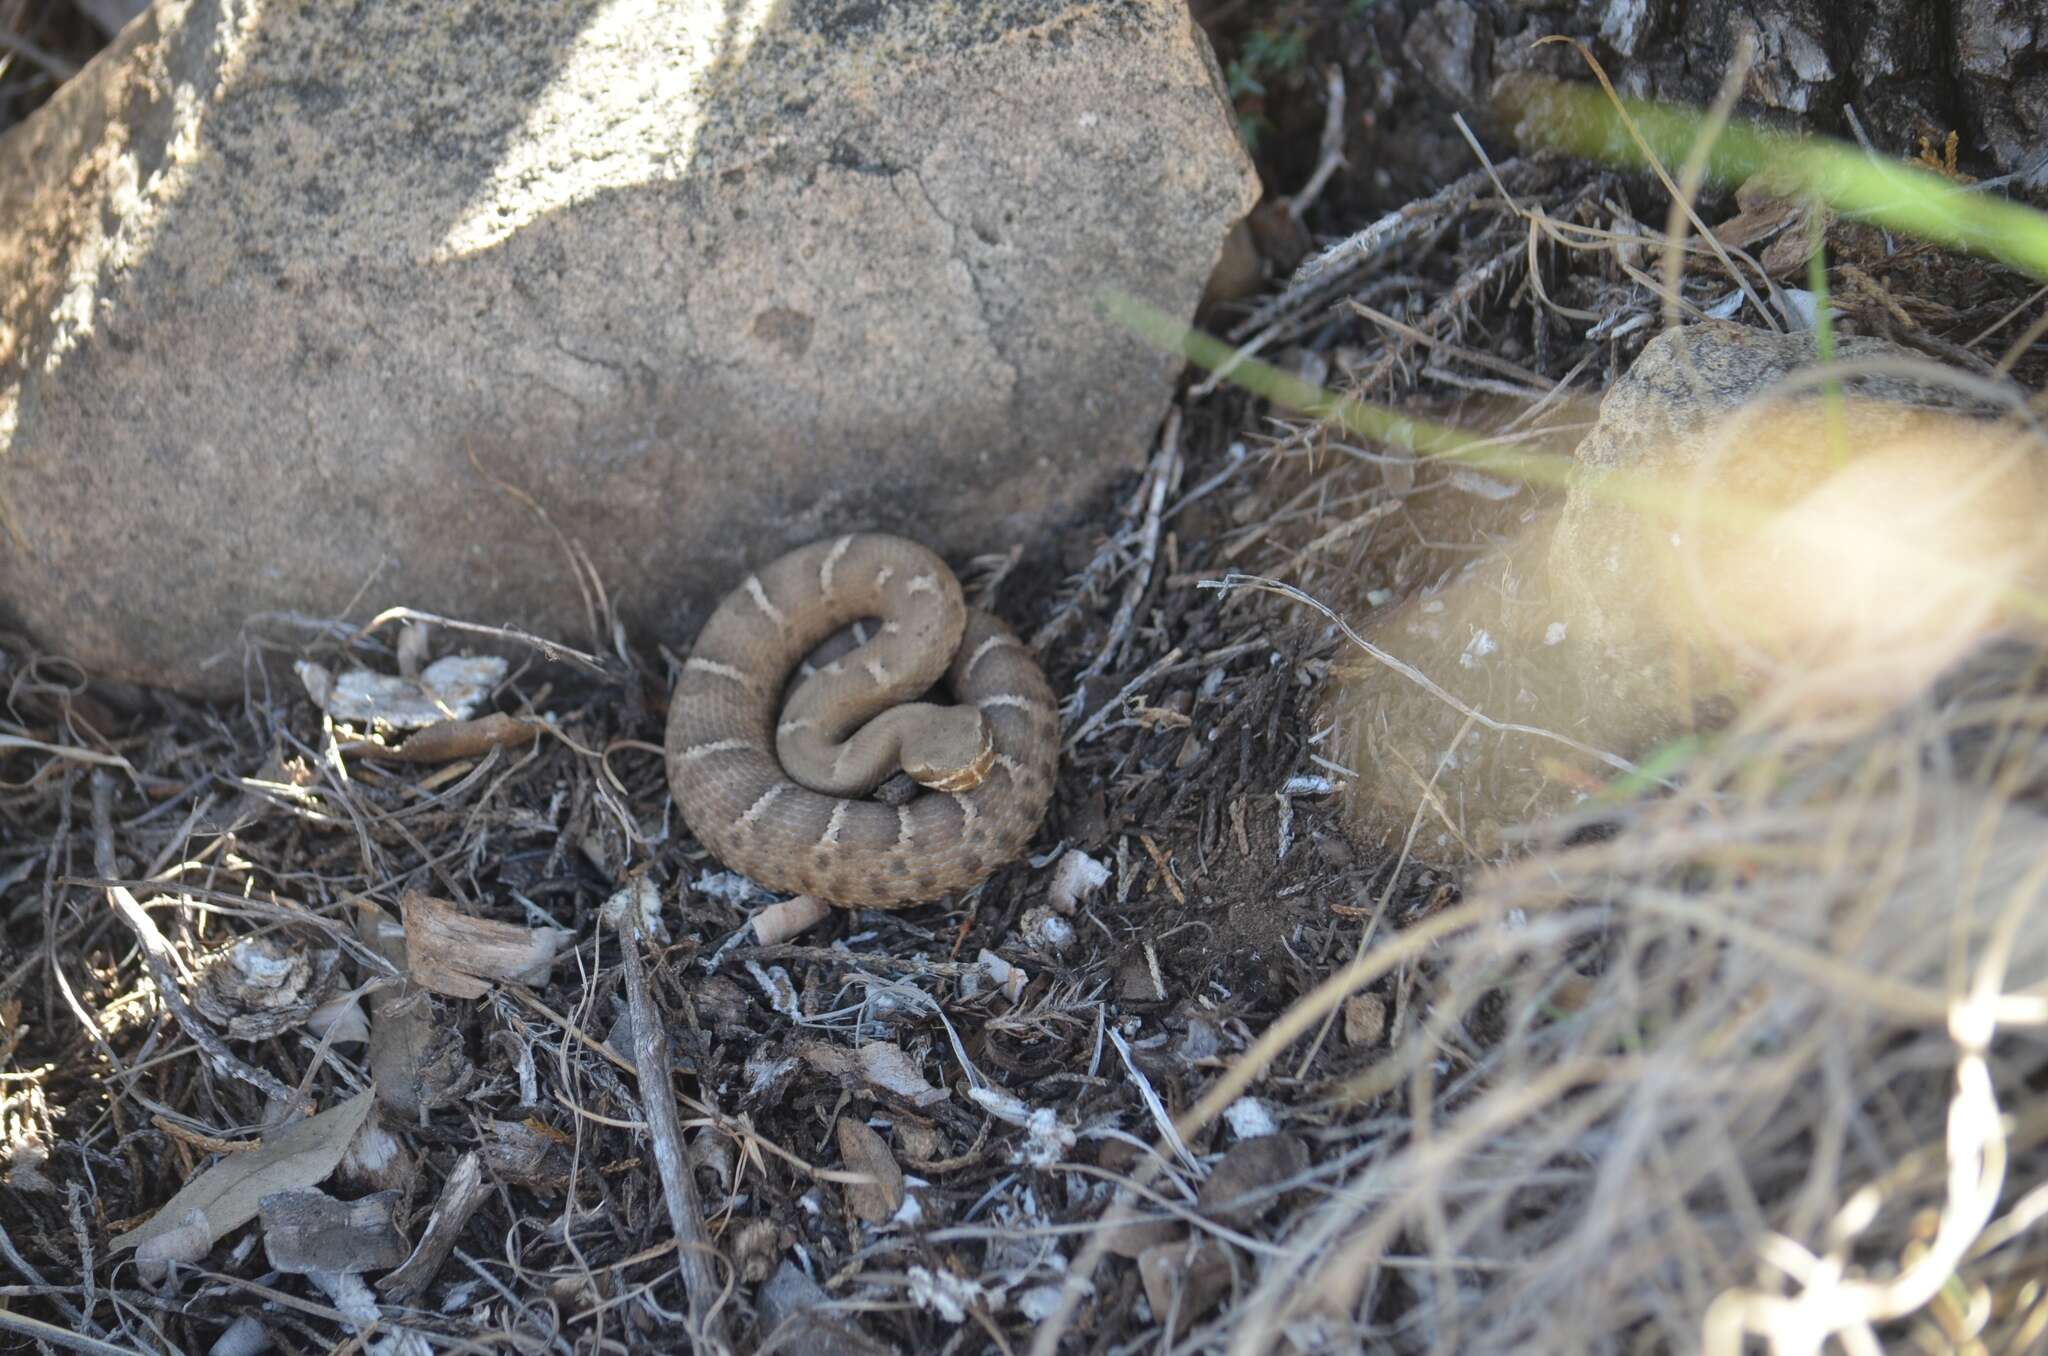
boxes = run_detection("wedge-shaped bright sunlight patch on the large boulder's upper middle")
[432,0,778,262]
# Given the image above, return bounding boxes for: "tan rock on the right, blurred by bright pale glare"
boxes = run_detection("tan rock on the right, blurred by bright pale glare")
[1542,322,2048,754]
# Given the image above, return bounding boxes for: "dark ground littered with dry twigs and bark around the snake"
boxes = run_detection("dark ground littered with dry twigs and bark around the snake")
[0,2,2048,1352]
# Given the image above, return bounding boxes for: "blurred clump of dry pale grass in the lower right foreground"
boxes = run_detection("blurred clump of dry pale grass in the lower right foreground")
[1219,643,2048,1354]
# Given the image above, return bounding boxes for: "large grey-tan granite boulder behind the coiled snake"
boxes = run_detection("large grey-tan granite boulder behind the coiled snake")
[0,0,1257,690]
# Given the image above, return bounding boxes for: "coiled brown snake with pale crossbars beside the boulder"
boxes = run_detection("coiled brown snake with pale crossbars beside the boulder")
[666,533,1059,909]
